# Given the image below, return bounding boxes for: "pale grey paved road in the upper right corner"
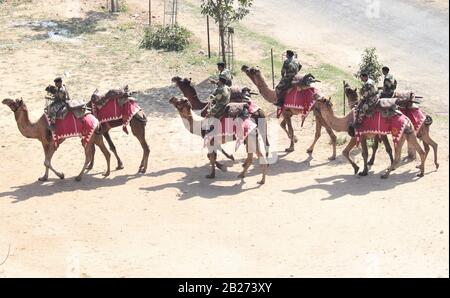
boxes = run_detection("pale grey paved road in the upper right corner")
[247,0,449,114]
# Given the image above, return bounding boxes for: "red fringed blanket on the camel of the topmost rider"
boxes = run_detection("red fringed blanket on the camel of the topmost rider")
[277,88,317,120]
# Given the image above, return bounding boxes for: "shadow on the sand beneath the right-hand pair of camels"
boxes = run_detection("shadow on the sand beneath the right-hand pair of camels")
[283,170,426,201]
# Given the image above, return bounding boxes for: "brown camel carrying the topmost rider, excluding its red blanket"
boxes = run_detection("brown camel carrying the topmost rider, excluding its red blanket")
[241,65,337,160]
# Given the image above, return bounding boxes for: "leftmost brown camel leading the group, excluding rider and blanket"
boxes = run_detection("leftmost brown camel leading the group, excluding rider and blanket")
[2,99,111,181]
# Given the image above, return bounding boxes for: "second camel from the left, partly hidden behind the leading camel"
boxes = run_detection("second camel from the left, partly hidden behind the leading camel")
[88,86,150,174]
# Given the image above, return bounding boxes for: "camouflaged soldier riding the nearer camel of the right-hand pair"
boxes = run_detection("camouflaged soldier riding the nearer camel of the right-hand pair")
[353,73,379,128]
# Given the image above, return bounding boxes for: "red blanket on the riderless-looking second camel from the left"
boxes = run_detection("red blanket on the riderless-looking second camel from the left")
[92,98,141,133]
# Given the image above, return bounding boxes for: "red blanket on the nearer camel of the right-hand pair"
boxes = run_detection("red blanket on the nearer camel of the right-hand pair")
[353,110,411,144]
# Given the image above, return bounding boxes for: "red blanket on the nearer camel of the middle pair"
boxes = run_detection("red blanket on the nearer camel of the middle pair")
[205,117,257,151]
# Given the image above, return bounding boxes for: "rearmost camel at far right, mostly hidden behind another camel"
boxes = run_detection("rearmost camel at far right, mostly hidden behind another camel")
[345,84,439,169]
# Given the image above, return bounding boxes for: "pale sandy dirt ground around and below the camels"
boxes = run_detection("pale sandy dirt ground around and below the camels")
[0,0,449,277]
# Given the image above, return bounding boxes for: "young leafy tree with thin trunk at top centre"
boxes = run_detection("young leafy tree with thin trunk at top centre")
[201,0,253,62]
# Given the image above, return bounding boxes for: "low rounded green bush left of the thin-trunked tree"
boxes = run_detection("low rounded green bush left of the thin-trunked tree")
[141,25,192,52]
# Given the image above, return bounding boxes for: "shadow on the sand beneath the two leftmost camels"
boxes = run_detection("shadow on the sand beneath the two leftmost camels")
[0,173,142,204]
